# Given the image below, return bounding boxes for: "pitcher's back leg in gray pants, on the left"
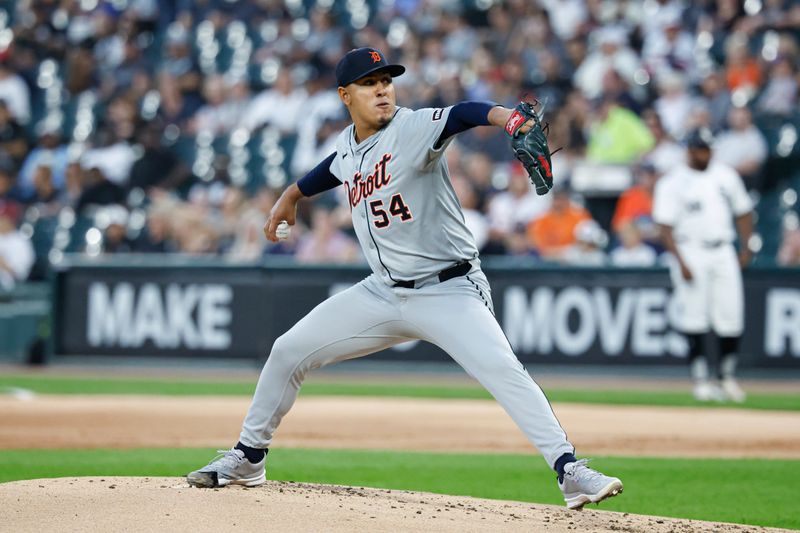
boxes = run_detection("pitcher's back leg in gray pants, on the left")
[239,282,409,448]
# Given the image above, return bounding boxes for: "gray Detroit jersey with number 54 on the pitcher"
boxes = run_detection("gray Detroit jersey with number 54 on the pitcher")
[331,107,478,285]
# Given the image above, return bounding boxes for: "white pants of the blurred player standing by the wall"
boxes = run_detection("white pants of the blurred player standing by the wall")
[670,243,744,337]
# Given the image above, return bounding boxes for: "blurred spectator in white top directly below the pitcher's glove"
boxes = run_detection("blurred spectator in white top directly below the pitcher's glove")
[488,162,550,255]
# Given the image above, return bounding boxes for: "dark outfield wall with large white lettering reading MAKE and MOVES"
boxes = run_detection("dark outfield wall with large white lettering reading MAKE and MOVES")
[53,256,800,368]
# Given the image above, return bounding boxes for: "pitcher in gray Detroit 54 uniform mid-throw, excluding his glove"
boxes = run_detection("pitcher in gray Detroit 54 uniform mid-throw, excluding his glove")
[187,48,622,508]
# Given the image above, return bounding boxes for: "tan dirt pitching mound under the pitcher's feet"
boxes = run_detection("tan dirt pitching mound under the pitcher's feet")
[0,477,778,533]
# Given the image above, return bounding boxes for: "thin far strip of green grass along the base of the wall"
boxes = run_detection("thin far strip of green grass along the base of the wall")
[0,375,800,411]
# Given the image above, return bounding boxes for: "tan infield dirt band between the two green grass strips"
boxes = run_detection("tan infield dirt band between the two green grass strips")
[0,395,800,459]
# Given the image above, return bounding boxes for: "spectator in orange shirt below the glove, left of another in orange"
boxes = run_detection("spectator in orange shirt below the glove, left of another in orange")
[527,187,592,260]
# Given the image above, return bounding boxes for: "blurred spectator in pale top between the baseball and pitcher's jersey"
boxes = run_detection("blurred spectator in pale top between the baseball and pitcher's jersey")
[295,207,361,263]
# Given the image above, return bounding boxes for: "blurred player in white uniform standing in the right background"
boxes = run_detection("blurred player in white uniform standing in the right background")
[653,129,753,402]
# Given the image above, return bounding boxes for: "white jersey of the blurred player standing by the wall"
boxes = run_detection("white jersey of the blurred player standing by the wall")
[653,162,753,244]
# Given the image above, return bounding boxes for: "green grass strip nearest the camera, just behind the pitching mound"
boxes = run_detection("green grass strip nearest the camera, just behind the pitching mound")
[0,448,800,529]
